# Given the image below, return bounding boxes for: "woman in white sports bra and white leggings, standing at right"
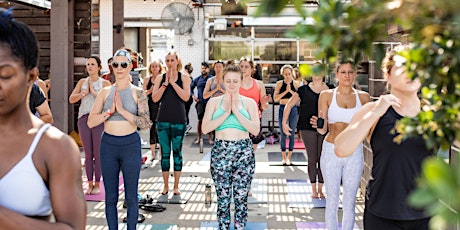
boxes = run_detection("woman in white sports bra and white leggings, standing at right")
[310,60,370,230]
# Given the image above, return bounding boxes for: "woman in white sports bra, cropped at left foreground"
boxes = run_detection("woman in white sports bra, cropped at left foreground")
[0,8,86,229]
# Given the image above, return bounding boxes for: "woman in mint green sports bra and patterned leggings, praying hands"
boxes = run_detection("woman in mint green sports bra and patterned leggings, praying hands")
[202,65,260,229]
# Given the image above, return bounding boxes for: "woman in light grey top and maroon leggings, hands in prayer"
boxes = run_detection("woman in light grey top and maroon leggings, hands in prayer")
[69,56,110,195]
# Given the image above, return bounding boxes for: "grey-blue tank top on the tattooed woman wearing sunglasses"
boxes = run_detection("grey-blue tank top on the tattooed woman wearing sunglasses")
[103,85,137,121]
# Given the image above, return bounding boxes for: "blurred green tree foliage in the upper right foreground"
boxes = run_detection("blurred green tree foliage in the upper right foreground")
[252,0,460,226]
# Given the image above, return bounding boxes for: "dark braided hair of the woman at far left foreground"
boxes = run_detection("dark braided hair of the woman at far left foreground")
[0,8,38,70]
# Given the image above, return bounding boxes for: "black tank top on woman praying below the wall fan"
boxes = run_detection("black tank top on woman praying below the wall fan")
[157,72,187,123]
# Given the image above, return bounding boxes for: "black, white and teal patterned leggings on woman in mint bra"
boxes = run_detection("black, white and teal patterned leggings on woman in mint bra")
[211,139,255,230]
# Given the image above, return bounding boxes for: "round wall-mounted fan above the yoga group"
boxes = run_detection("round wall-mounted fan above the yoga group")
[161,2,195,35]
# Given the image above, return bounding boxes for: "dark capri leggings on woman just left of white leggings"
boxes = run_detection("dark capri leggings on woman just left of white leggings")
[300,130,324,183]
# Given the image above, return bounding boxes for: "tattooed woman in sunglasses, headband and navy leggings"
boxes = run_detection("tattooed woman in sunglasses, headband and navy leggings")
[88,50,151,229]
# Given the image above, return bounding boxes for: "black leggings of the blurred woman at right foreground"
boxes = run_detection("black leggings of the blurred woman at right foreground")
[364,208,430,230]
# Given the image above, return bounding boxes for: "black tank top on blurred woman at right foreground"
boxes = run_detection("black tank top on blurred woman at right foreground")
[366,107,432,220]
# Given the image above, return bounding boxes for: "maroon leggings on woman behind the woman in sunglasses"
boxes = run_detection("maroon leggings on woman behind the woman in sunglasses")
[77,114,104,182]
